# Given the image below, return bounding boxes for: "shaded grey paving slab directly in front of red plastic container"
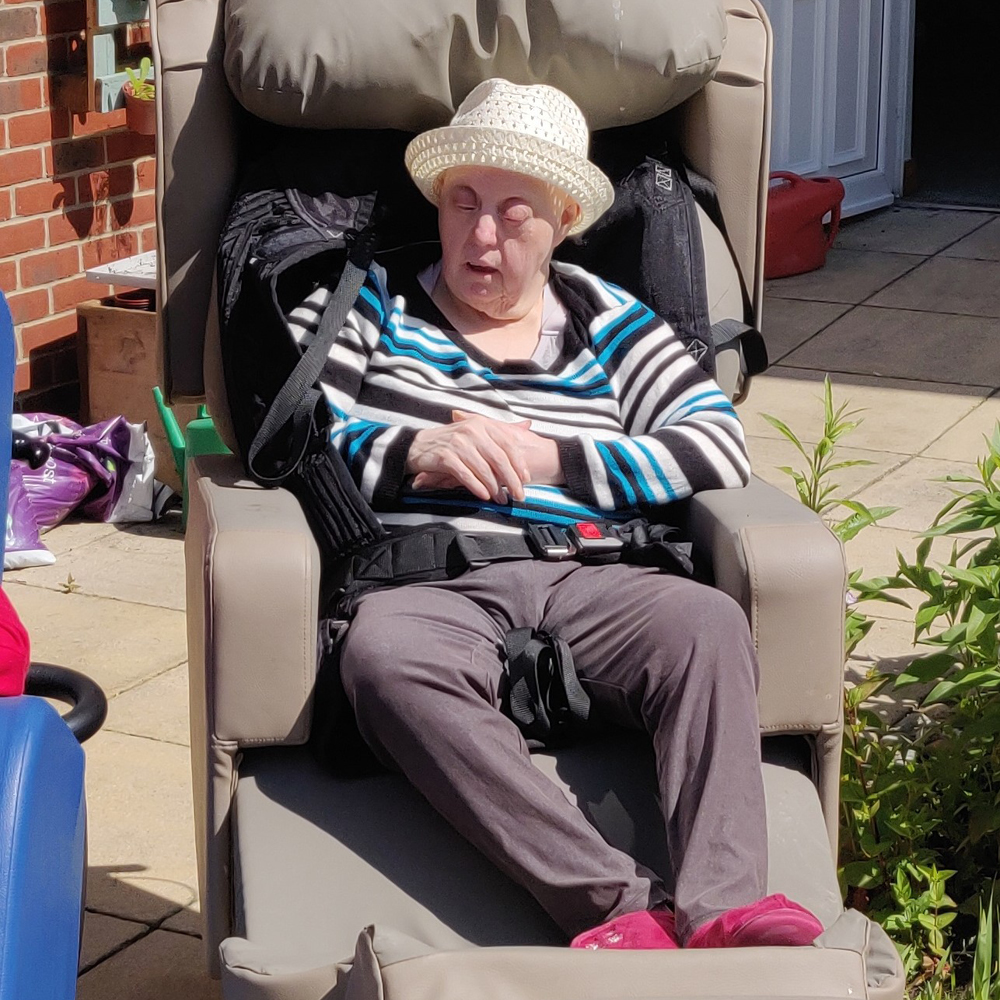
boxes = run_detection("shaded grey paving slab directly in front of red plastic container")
[764,248,926,304]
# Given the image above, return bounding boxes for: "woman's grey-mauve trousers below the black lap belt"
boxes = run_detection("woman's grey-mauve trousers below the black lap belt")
[341,560,767,940]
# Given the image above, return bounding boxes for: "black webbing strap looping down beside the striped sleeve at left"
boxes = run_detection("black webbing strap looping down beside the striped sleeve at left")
[247,224,375,485]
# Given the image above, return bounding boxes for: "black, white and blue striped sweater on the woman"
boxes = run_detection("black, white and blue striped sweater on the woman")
[290,262,749,530]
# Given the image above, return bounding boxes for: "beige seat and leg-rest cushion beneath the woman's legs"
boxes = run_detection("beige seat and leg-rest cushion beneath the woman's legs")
[235,737,842,962]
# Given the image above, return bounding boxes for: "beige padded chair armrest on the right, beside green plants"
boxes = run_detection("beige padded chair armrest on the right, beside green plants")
[687,478,847,732]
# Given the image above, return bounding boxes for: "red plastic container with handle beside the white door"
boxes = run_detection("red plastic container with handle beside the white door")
[764,170,844,278]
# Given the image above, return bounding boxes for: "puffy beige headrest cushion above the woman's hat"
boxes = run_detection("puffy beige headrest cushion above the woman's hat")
[225,0,726,131]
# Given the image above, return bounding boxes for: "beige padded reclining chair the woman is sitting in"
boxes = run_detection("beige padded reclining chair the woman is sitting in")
[153,0,903,1000]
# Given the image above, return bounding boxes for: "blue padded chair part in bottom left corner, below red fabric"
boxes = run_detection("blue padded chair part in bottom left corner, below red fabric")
[0,696,86,1000]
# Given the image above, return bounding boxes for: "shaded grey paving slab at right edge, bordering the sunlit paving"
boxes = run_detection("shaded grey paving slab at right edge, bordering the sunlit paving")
[784,304,1000,386]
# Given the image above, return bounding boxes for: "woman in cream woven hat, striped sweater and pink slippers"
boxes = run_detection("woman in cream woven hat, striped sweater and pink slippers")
[297,80,822,948]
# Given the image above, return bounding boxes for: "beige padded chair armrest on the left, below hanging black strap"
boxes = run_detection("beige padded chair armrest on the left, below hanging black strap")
[184,455,320,746]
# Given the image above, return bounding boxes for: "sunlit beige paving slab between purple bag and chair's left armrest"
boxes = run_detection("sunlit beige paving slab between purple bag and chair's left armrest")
[9,525,184,611]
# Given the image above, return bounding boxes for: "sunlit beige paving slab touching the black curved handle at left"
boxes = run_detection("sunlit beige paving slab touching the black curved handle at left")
[4,575,187,696]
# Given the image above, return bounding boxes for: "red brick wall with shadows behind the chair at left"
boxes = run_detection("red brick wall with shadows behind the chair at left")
[0,0,156,416]
